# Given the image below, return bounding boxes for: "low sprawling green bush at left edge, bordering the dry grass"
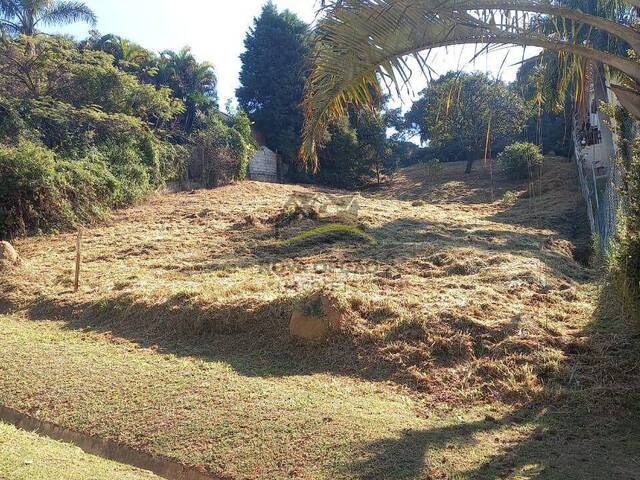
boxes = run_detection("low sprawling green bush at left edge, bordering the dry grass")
[0,140,168,237]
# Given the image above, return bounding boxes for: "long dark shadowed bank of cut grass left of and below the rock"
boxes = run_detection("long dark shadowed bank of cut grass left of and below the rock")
[27,294,400,381]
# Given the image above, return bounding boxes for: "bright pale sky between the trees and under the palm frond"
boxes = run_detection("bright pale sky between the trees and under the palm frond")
[50,0,536,109]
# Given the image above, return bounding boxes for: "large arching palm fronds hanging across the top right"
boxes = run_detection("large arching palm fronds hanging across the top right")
[300,0,640,167]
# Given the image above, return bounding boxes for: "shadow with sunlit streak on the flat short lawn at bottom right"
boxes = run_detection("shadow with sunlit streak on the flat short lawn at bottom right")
[348,406,640,480]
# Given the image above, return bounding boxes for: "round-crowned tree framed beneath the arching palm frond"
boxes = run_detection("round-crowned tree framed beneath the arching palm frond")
[407,72,527,173]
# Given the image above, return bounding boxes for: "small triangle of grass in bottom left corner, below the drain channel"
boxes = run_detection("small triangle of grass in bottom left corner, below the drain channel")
[0,422,160,480]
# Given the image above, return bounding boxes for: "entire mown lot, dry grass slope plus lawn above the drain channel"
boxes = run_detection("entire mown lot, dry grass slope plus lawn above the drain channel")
[0,158,640,480]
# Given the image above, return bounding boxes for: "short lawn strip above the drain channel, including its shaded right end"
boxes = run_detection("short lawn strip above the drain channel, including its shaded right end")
[0,316,640,480]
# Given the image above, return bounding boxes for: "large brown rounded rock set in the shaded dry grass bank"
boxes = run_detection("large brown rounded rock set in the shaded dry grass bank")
[289,291,344,341]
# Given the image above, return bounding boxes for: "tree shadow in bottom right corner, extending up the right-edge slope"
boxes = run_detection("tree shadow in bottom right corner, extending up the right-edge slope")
[348,290,640,480]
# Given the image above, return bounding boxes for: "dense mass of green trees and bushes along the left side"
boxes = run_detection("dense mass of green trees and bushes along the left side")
[0,29,248,237]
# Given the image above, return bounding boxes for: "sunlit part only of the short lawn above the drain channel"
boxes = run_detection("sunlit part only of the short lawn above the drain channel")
[0,317,440,478]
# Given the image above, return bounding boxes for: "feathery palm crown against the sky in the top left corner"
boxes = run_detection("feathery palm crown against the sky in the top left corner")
[0,0,96,35]
